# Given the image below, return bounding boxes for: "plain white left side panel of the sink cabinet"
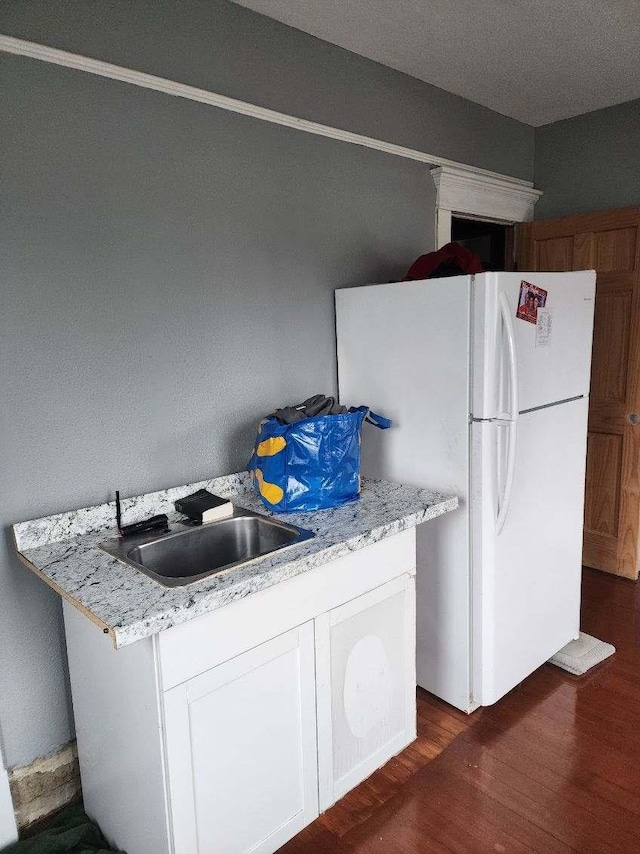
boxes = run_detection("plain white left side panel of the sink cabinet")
[62,600,171,854]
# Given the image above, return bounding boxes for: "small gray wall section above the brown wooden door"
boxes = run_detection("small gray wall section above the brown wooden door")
[535,100,640,219]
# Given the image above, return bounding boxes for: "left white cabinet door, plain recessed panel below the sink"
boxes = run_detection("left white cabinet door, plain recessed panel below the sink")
[164,621,318,854]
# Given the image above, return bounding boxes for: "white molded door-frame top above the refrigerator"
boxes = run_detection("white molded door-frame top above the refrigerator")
[431,166,542,249]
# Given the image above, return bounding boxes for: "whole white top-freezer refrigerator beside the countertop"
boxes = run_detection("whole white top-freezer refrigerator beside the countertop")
[335,271,595,712]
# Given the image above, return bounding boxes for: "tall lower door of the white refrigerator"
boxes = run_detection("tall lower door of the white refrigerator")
[471,398,588,705]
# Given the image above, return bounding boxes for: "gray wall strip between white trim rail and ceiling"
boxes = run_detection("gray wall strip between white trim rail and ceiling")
[0,0,534,180]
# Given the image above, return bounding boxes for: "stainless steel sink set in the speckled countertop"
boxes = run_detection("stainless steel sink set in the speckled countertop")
[99,508,314,587]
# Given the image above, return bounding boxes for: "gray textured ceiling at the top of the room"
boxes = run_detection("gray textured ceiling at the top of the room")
[234,0,640,126]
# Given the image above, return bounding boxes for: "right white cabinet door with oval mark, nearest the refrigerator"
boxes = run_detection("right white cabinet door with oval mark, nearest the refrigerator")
[316,575,416,811]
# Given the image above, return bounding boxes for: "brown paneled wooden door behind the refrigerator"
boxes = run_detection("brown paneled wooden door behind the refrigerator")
[518,207,640,579]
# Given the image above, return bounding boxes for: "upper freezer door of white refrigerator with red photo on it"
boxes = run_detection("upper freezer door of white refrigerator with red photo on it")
[472,270,595,419]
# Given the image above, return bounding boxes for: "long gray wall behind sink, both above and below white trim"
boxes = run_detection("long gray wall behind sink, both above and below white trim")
[0,0,533,765]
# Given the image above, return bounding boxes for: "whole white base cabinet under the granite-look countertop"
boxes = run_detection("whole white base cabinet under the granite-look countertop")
[64,529,416,854]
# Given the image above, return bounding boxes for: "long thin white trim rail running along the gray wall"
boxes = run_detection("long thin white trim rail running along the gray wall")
[0,34,533,188]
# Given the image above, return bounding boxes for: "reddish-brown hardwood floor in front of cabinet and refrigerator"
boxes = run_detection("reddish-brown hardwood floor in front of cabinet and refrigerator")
[280,569,640,854]
